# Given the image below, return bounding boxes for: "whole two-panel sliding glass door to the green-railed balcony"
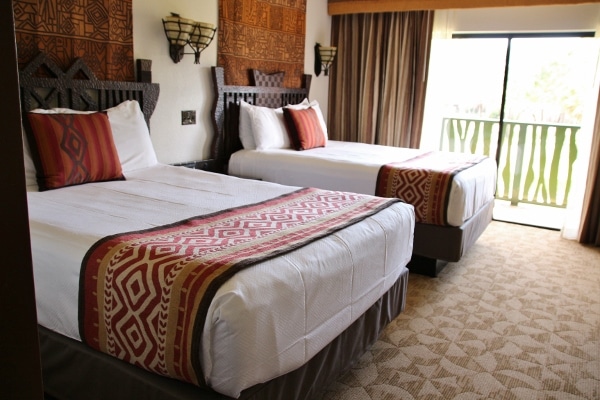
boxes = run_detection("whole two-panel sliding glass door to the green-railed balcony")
[421,34,598,228]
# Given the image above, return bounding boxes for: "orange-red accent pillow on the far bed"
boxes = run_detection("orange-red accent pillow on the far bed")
[283,107,326,150]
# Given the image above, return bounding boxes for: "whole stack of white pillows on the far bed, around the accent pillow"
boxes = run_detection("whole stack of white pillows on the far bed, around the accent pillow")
[239,99,328,150]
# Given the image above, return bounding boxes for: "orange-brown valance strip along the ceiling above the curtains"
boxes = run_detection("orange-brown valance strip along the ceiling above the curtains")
[327,0,598,15]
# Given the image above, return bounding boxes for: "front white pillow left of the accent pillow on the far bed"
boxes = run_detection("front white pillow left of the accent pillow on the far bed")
[250,106,291,150]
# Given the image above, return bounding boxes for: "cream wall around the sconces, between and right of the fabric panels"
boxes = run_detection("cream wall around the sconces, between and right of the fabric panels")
[133,0,331,163]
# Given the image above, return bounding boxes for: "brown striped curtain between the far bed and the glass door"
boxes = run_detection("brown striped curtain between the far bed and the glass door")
[328,11,433,148]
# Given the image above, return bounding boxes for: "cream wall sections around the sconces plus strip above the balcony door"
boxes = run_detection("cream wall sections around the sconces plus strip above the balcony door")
[133,0,600,163]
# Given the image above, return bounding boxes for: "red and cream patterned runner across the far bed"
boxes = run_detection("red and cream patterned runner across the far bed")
[375,151,486,225]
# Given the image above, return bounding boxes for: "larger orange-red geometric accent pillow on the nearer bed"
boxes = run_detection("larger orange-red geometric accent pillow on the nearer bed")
[28,113,125,191]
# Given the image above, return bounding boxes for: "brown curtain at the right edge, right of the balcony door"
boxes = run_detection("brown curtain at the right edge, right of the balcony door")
[579,86,600,246]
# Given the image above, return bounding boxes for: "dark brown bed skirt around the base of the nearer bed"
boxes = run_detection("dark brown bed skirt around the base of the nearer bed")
[39,270,408,400]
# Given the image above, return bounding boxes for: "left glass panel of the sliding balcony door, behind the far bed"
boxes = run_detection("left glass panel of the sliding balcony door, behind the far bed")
[421,38,508,156]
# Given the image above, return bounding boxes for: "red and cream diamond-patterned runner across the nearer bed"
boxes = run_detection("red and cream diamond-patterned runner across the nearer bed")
[79,189,398,386]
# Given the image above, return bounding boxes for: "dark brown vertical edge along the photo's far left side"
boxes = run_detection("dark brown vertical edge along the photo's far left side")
[0,1,44,400]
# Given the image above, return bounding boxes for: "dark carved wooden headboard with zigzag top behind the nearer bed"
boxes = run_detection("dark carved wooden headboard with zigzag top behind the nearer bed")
[19,53,160,126]
